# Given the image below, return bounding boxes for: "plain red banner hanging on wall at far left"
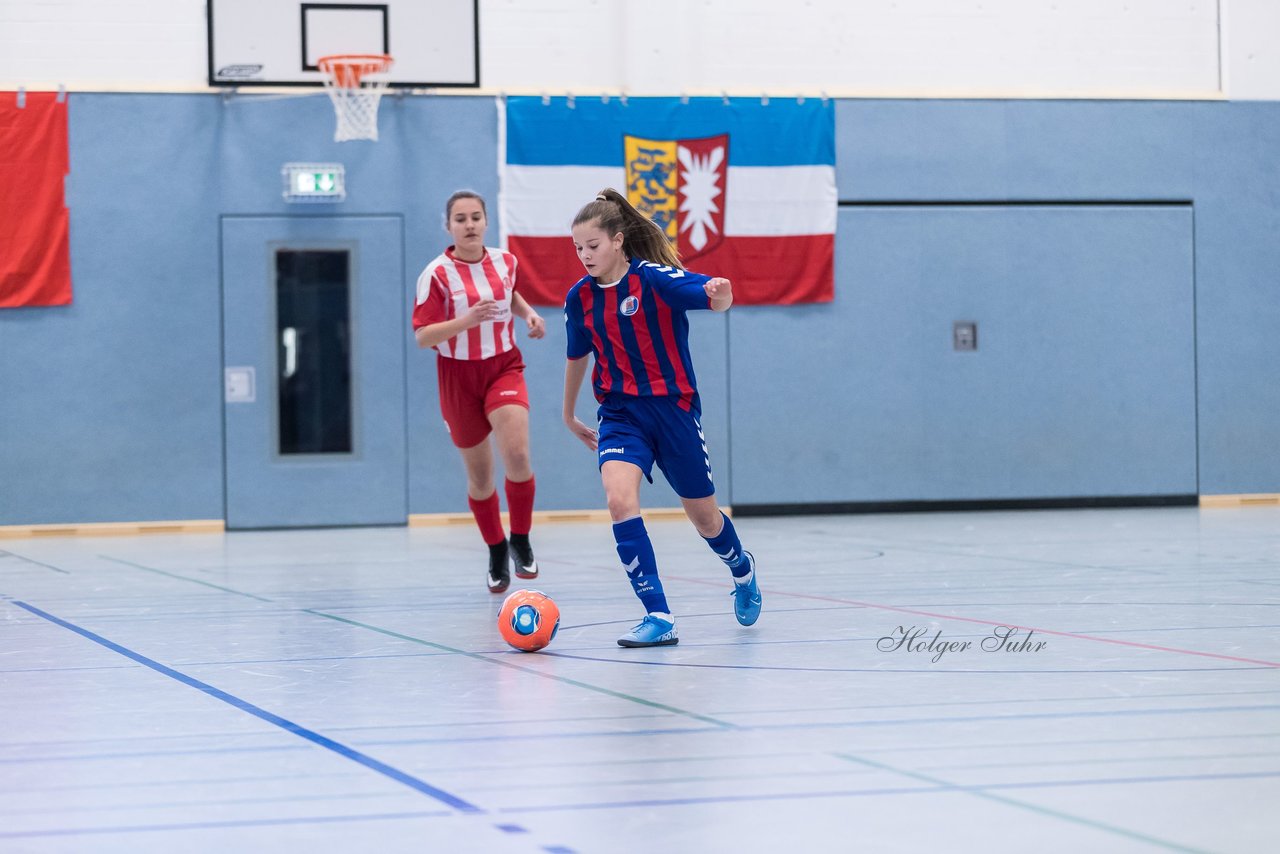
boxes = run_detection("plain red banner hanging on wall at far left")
[0,92,72,309]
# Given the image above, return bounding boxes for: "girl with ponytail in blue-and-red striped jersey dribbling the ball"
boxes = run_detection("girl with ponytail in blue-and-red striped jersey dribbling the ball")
[563,189,760,647]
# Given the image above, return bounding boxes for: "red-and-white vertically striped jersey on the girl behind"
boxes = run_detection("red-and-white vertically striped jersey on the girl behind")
[413,246,516,360]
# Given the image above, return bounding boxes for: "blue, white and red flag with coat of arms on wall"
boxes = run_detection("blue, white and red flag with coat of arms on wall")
[498,96,837,305]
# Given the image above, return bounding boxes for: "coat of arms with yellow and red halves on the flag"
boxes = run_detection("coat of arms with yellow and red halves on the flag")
[623,133,728,260]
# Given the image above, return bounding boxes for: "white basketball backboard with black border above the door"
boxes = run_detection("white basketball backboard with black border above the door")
[207,0,480,88]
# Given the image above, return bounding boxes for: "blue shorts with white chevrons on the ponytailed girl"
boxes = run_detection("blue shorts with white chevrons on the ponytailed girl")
[596,394,716,498]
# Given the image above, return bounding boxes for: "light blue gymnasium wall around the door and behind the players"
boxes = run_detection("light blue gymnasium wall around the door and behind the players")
[0,93,1280,525]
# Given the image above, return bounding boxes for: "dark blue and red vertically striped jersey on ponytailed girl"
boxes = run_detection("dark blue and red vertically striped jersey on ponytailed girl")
[564,259,710,410]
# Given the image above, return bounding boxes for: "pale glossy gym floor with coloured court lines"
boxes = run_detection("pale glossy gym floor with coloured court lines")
[0,507,1280,854]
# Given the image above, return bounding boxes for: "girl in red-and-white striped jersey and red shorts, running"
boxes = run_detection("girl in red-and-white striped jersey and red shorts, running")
[413,189,547,593]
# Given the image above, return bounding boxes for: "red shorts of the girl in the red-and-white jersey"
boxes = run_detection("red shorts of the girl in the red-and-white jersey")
[435,348,529,448]
